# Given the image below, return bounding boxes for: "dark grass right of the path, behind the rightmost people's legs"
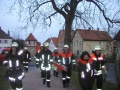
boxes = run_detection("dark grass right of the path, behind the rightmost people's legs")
[70,71,119,90]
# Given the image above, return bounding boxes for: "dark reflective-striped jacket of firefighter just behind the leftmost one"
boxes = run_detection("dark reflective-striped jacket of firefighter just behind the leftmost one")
[18,50,31,62]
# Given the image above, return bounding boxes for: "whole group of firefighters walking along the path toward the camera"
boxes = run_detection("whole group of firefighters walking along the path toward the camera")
[3,42,106,90]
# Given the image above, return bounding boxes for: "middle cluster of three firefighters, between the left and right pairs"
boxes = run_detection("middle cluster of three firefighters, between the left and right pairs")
[35,43,75,88]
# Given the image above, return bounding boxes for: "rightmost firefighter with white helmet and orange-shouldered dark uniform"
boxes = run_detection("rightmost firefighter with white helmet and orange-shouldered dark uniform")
[91,46,107,90]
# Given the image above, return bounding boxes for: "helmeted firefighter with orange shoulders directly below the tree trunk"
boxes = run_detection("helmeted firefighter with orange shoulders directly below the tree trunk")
[61,45,75,88]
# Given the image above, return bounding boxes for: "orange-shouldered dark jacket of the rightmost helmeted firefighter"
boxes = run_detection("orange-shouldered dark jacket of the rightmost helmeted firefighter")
[91,53,105,75]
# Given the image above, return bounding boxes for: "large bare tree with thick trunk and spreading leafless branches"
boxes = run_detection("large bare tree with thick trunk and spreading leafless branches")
[7,0,120,45]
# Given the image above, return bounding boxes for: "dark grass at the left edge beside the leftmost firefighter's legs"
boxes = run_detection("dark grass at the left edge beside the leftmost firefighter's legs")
[0,65,10,90]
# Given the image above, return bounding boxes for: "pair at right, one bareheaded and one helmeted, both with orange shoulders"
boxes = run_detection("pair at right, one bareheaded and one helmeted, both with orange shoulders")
[78,46,107,90]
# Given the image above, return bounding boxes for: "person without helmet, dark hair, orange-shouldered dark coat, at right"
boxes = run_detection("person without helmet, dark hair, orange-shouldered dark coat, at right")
[78,51,94,90]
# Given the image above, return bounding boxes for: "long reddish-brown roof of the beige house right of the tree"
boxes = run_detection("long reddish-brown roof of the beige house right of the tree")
[76,29,112,41]
